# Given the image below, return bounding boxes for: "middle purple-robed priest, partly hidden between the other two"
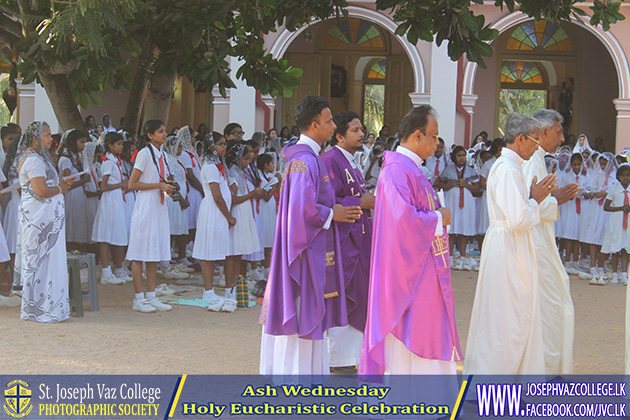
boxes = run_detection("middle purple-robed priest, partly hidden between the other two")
[322,112,374,374]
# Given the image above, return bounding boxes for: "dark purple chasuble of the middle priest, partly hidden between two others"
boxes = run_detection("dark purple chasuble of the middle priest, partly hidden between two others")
[322,147,372,332]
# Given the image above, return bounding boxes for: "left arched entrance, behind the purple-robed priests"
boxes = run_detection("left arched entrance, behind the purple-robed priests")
[270,6,425,135]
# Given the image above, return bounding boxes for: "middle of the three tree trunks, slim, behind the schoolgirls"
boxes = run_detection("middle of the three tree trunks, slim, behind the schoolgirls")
[123,37,155,139]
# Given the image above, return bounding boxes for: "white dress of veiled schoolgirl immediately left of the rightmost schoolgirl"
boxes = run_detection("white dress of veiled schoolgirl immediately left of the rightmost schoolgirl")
[580,174,617,246]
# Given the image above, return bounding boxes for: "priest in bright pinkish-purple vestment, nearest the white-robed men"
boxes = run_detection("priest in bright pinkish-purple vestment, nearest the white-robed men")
[359,105,462,375]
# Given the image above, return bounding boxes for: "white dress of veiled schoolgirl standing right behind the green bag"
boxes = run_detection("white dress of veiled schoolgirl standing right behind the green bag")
[227,165,260,256]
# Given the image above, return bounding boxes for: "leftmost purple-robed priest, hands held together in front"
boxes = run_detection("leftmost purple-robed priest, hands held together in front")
[260,96,362,375]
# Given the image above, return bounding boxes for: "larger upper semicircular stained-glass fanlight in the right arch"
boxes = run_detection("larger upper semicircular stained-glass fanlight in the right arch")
[506,20,573,51]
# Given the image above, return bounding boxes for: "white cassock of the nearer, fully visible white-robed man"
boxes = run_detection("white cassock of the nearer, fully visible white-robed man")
[464,147,545,375]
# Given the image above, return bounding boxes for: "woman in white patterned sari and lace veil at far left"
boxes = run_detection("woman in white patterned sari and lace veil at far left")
[14,121,73,322]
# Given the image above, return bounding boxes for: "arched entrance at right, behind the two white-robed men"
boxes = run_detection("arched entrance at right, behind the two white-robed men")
[463,12,630,151]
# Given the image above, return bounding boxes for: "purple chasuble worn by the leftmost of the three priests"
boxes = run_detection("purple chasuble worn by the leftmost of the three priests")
[260,144,348,340]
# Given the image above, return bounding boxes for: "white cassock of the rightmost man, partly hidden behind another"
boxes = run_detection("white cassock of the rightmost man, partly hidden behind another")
[523,147,574,375]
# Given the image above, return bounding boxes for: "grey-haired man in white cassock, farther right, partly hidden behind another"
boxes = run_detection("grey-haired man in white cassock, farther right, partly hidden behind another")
[523,109,580,375]
